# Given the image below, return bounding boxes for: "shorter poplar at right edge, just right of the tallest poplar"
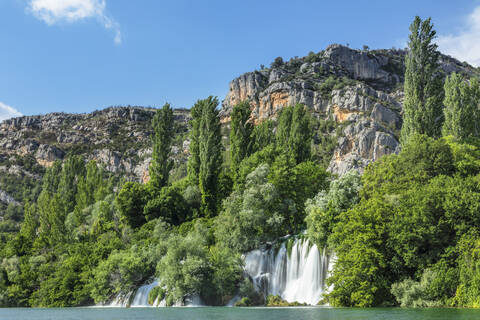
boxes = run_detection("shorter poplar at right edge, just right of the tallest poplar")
[442,73,480,140]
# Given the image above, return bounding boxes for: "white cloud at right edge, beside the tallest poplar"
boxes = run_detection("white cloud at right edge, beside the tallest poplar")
[437,7,480,67]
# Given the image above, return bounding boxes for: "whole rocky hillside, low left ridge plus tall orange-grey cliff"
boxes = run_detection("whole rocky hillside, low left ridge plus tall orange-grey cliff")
[0,44,479,232]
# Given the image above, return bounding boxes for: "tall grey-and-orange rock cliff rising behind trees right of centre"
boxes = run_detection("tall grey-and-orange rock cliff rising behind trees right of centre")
[221,44,478,174]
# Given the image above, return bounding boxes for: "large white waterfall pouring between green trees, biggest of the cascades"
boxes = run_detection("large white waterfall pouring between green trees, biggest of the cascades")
[245,239,331,305]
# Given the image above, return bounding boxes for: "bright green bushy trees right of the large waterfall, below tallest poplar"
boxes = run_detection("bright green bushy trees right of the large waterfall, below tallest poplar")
[322,135,480,306]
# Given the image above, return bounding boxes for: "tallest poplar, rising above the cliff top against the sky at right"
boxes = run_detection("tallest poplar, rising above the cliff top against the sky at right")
[401,16,443,143]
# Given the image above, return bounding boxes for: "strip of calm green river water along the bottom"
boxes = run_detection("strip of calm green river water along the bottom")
[0,307,480,320]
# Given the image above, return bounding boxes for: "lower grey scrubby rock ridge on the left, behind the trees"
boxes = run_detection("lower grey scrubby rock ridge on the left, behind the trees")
[0,107,190,211]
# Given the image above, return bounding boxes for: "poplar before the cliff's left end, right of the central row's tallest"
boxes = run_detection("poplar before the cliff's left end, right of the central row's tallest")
[230,101,254,180]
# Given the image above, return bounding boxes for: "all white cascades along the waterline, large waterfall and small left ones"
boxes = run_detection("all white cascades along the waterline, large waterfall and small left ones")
[109,239,333,307]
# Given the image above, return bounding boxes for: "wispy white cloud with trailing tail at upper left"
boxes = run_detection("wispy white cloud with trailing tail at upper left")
[28,0,122,44]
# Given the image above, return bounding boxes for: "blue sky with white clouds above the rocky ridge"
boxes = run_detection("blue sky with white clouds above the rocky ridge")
[0,0,480,120]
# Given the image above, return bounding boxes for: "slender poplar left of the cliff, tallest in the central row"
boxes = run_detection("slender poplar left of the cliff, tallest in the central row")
[198,96,223,216]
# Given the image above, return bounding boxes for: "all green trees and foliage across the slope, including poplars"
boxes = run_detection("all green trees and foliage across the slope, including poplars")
[0,17,480,307]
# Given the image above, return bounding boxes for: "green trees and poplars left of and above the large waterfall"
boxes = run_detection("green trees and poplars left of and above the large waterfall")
[0,97,329,307]
